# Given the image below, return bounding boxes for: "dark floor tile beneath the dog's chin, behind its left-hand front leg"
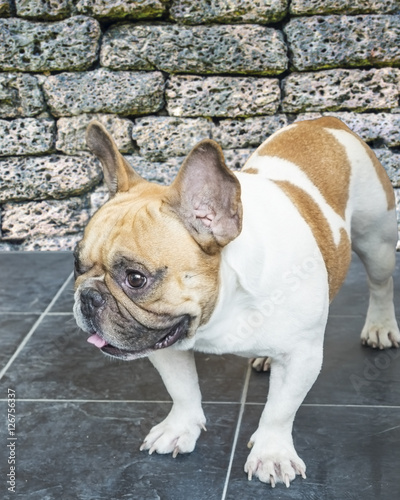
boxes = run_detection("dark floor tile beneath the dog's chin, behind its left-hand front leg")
[0,315,247,402]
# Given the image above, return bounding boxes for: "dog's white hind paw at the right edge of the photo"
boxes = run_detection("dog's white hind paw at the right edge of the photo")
[361,318,400,349]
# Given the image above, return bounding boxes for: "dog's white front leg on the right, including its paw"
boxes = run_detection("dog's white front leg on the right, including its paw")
[244,345,322,487]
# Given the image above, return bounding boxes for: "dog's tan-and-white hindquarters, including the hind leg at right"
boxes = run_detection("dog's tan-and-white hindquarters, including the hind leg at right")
[243,117,400,348]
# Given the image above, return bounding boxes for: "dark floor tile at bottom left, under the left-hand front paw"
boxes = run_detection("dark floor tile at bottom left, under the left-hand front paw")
[0,402,238,500]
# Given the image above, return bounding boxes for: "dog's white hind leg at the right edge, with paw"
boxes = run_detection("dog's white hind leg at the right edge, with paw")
[352,205,400,349]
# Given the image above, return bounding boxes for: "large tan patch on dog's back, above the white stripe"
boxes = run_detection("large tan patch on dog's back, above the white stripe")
[257,117,351,218]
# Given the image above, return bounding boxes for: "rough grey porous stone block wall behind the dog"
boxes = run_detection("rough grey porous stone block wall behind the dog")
[0,0,400,250]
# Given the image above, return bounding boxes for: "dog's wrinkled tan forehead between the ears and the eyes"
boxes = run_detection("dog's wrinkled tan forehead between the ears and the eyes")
[75,190,200,284]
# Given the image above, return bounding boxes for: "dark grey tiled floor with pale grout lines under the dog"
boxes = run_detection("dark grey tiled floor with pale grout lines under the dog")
[0,253,400,500]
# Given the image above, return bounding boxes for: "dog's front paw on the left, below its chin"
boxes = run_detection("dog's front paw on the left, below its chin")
[140,412,206,458]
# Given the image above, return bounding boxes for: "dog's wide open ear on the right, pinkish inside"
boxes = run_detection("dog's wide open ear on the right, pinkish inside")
[169,139,242,254]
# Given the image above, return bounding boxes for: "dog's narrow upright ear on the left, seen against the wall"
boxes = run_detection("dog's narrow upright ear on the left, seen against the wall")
[86,120,146,197]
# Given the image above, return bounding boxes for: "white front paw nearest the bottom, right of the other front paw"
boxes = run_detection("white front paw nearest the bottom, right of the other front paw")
[244,441,306,488]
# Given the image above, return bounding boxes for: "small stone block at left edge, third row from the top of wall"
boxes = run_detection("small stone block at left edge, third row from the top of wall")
[0,73,45,118]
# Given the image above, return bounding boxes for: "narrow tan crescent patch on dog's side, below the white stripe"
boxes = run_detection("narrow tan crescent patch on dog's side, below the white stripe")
[274,181,351,301]
